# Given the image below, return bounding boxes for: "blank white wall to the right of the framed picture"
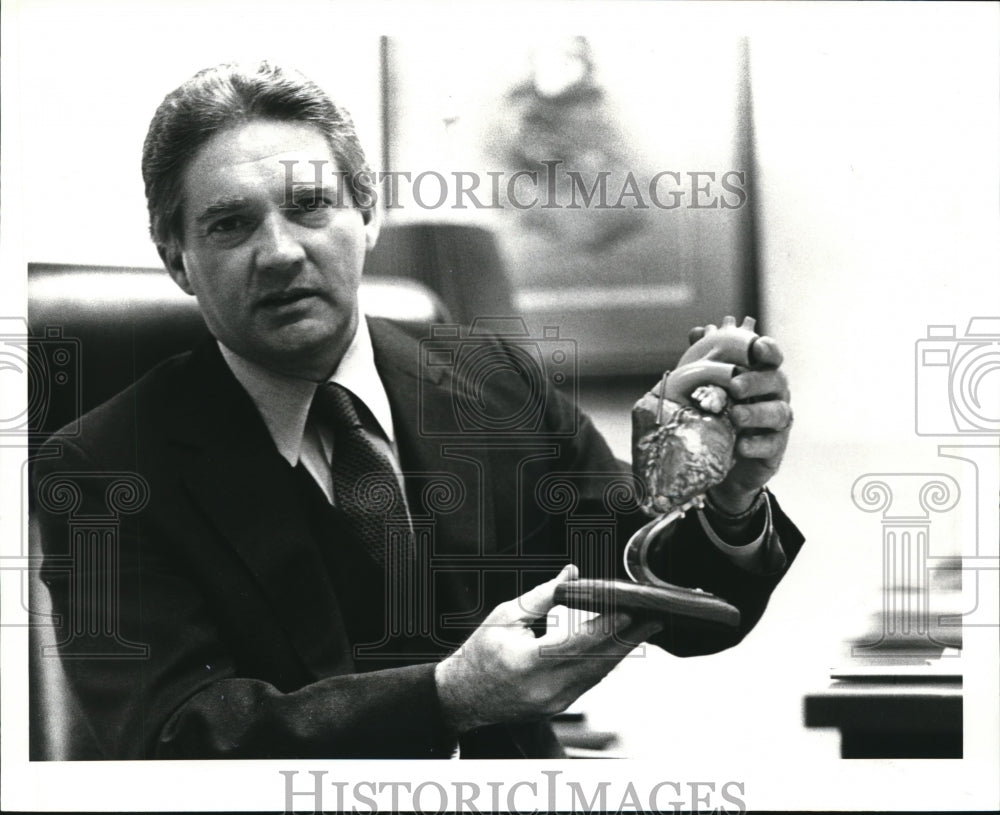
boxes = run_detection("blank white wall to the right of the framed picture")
[752,4,1000,684]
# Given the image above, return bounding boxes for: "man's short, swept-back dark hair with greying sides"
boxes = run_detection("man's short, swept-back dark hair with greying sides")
[142,61,372,246]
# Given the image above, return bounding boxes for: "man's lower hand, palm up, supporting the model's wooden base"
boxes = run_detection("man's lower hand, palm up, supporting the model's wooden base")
[435,566,661,733]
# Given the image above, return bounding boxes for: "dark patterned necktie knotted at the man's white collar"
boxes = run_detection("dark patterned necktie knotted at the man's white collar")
[312,382,413,574]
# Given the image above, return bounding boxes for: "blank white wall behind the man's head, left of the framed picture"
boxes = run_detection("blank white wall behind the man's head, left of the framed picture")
[4,0,381,266]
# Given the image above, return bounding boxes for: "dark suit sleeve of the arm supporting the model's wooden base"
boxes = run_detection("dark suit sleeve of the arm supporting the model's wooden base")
[33,442,454,760]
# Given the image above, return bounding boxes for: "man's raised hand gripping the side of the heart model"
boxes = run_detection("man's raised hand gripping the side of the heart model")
[691,329,792,515]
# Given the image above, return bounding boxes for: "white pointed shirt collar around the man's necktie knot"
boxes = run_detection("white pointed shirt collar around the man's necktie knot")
[218,314,396,467]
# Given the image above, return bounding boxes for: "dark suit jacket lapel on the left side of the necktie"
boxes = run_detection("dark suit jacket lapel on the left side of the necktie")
[164,342,350,676]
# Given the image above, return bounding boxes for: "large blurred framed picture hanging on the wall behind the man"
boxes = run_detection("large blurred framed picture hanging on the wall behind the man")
[384,31,760,375]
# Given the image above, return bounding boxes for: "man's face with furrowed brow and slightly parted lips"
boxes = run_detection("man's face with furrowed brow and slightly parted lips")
[168,120,377,379]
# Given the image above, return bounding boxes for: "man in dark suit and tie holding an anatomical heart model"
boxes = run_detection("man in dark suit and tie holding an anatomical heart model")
[34,63,801,759]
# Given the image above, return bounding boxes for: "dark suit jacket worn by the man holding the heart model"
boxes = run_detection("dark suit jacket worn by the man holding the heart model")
[33,321,801,759]
